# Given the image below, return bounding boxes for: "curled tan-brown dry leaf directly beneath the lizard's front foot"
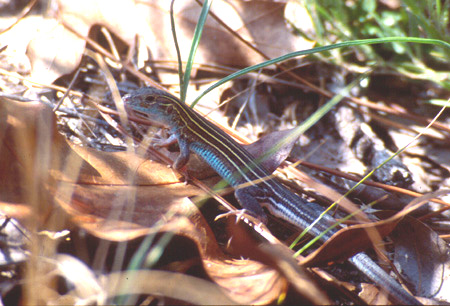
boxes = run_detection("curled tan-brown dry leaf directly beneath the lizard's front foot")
[49,140,213,241]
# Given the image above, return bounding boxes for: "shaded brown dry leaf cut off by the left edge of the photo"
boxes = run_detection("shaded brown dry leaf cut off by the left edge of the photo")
[0,98,74,230]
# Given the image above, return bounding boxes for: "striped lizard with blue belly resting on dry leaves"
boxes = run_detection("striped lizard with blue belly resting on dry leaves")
[123,87,420,304]
